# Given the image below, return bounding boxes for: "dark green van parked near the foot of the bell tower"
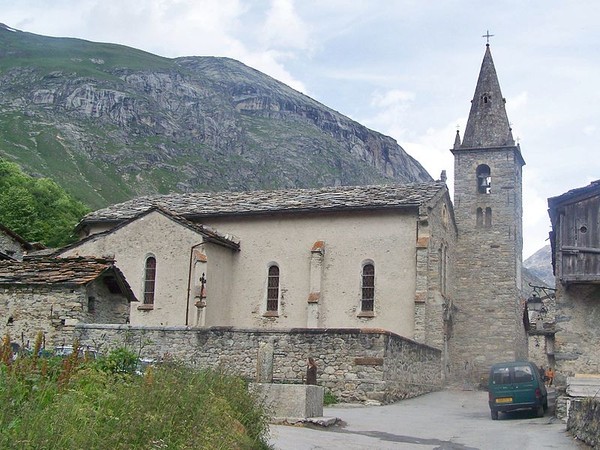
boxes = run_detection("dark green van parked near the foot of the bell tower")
[488,361,548,420]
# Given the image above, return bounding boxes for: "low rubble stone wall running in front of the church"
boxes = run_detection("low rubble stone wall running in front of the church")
[75,324,442,403]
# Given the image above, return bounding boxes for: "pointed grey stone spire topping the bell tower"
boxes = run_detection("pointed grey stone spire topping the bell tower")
[462,44,515,148]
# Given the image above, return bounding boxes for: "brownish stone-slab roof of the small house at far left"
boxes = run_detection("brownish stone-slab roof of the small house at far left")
[0,258,136,301]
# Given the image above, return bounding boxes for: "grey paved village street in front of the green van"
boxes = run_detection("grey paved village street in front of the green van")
[270,391,589,450]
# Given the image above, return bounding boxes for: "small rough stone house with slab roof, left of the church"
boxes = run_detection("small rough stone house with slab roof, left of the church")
[0,258,137,347]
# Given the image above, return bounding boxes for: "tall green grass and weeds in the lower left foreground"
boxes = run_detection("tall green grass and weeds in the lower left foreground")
[0,338,269,449]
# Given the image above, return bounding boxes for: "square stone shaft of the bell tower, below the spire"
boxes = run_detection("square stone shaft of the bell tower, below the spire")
[449,147,527,385]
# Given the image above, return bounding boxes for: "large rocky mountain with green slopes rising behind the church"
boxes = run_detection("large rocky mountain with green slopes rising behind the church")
[0,24,431,208]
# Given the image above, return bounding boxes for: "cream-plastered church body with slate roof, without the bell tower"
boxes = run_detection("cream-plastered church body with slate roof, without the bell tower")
[56,182,457,348]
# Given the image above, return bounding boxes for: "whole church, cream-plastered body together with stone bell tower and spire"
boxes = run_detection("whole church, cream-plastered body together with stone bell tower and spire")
[17,46,527,388]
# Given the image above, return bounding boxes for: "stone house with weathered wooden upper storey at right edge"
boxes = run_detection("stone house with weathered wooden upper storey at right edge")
[548,180,600,384]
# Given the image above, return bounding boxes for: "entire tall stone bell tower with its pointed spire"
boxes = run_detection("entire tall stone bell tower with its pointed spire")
[447,43,527,383]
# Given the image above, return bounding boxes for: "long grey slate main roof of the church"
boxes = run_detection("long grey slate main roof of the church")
[79,182,446,227]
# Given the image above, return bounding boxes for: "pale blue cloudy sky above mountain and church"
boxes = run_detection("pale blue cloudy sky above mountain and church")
[0,0,600,258]
